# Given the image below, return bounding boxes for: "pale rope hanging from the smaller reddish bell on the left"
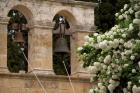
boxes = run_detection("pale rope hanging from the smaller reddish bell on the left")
[20,48,48,93]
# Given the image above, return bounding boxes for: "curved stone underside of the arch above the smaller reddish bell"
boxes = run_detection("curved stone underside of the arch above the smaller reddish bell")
[7,4,33,25]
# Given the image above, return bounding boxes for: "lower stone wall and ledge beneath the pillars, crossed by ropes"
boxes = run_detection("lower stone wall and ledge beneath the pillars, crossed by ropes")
[0,73,91,93]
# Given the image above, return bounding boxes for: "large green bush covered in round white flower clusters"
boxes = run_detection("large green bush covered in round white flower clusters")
[78,0,140,93]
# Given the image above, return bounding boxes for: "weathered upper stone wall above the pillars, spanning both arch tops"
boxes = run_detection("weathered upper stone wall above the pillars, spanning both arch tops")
[0,0,96,28]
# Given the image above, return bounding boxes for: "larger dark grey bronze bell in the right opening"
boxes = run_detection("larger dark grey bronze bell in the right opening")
[54,37,69,53]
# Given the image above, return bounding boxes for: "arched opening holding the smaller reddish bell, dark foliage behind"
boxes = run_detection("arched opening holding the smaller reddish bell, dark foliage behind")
[7,9,29,73]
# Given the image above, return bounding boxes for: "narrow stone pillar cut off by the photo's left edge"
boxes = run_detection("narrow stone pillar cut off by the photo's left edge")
[0,17,9,73]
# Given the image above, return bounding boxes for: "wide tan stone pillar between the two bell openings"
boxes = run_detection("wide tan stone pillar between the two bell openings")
[28,23,54,74]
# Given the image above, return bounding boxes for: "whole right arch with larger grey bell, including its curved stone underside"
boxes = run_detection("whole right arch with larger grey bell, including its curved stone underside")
[52,10,73,75]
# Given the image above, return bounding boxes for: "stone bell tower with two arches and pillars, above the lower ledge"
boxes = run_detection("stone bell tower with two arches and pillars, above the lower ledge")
[0,0,96,76]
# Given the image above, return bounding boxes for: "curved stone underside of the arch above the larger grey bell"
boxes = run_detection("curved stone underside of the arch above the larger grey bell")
[56,10,77,26]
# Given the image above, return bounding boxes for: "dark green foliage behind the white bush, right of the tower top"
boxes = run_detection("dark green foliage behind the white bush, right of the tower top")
[95,0,130,32]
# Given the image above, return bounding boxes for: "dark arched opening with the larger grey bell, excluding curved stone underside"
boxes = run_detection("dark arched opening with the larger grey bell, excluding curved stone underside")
[53,14,71,75]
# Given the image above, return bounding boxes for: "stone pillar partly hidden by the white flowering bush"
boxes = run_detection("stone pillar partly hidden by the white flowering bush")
[71,25,94,78]
